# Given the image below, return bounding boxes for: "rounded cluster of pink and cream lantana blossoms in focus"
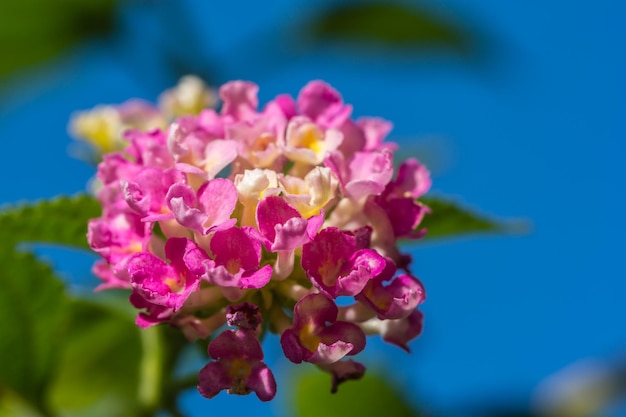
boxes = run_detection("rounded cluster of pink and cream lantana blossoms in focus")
[88,81,430,401]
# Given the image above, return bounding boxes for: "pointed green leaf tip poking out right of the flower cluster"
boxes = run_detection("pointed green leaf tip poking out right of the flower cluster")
[419,197,524,240]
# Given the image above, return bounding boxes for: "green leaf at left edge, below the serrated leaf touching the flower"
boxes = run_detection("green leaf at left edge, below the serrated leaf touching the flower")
[0,250,67,410]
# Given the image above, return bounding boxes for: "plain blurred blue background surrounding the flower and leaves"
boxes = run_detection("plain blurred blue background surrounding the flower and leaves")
[0,0,626,416]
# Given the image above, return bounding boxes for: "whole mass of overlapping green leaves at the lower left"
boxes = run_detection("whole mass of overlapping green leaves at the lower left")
[0,195,141,416]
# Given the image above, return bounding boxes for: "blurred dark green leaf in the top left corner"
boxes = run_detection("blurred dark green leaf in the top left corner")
[0,0,117,79]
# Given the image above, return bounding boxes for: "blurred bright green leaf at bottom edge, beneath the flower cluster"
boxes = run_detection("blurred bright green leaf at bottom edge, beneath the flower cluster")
[292,370,419,417]
